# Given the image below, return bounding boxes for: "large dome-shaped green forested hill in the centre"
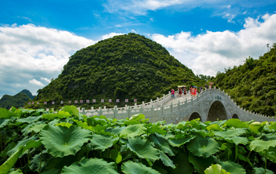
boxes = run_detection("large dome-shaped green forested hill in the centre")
[34,33,203,107]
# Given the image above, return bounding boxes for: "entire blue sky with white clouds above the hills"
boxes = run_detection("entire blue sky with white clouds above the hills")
[0,0,276,97]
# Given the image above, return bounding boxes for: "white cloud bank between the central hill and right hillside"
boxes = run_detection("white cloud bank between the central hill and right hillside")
[151,14,276,75]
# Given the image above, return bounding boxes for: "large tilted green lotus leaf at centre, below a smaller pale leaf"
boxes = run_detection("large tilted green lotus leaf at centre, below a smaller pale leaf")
[127,137,159,161]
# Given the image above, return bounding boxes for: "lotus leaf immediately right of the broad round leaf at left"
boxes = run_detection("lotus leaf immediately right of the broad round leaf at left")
[88,134,119,151]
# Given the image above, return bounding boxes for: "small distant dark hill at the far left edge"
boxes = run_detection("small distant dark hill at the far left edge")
[0,89,34,109]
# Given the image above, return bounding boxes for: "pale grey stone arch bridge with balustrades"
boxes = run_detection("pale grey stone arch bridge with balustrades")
[80,88,276,124]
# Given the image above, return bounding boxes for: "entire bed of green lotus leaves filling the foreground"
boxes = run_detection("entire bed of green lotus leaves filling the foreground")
[0,106,276,174]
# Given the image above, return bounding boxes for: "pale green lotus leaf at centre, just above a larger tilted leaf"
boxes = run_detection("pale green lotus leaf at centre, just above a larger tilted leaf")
[120,124,146,137]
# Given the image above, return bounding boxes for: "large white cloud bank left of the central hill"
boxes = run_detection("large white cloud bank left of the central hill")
[0,24,95,95]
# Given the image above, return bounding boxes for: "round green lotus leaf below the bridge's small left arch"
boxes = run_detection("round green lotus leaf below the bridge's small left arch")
[187,137,220,158]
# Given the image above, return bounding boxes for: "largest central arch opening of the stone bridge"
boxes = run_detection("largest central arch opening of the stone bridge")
[207,101,227,121]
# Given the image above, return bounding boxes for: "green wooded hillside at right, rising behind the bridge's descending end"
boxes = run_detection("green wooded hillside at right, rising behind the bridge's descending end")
[214,44,276,116]
